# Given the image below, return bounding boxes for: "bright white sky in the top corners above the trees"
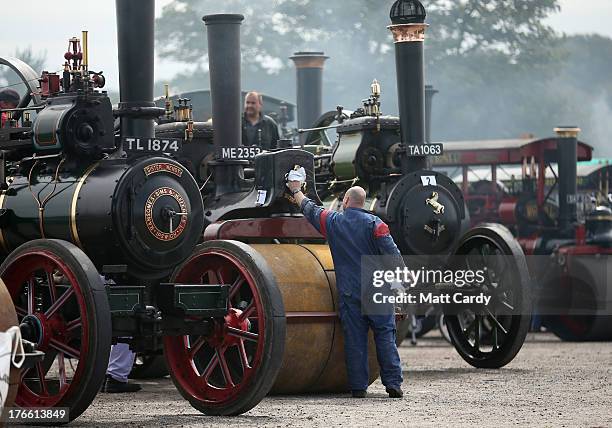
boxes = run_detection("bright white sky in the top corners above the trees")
[0,0,612,89]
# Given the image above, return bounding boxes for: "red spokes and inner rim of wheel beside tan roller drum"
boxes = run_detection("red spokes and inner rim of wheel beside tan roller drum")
[163,249,269,407]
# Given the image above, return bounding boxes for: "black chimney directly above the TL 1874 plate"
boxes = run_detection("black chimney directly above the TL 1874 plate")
[115,0,158,137]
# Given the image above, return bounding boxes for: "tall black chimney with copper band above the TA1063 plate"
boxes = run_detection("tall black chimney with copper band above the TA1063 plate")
[388,0,427,173]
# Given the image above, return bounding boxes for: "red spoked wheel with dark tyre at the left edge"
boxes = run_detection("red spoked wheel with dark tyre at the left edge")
[0,239,112,420]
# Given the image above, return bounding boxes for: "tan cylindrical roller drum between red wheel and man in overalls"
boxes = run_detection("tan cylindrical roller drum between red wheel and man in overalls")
[252,244,378,394]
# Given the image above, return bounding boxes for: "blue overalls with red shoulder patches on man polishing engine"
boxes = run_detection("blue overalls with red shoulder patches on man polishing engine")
[301,199,402,391]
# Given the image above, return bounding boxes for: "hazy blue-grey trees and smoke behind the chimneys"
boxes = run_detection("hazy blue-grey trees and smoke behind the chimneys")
[157,0,612,154]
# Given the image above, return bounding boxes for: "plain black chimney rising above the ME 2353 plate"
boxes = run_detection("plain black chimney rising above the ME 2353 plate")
[202,14,248,196]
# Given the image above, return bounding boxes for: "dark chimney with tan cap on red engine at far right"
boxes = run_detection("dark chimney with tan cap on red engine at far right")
[555,126,580,234]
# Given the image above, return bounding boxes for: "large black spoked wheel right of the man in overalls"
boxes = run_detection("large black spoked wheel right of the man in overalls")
[444,224,531,368]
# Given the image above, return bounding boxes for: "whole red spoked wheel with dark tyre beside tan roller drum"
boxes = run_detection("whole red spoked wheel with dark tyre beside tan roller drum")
[164,241,286,415]
